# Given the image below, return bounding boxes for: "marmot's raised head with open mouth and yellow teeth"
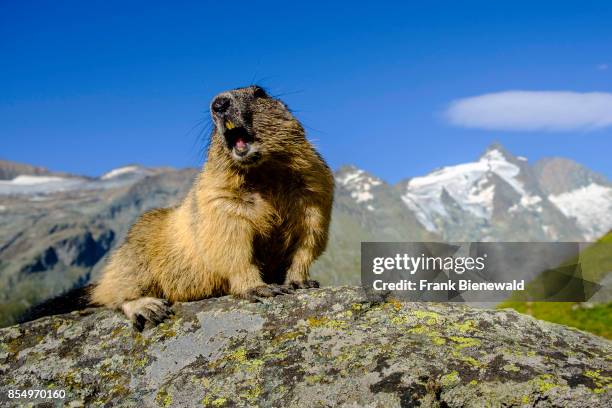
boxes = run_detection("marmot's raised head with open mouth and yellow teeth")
[210,86,305,166]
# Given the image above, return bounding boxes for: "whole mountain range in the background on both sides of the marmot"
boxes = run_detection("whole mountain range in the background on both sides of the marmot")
[0,145,612,325]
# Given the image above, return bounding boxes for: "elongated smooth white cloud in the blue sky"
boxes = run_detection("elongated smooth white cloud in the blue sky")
[446,91,612,131]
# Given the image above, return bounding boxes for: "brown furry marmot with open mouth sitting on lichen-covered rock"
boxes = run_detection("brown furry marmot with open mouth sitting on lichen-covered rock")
[91,86,333,329]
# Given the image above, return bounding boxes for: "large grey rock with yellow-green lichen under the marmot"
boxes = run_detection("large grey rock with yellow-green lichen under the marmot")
[0,287,612,407]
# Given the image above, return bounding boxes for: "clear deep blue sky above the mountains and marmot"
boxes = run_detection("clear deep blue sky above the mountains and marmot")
[0,1,612,182]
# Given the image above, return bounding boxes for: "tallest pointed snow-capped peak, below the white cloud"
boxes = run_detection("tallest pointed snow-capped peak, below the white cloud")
[400,144,584,241]
